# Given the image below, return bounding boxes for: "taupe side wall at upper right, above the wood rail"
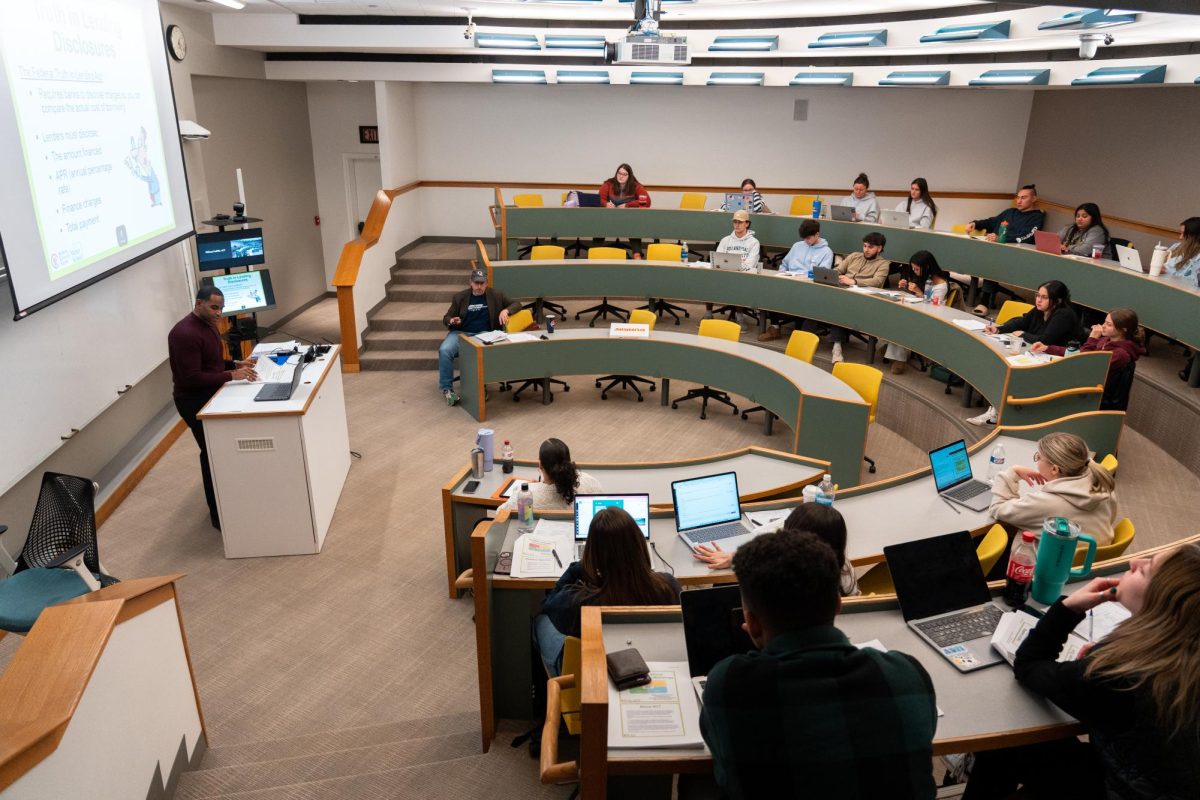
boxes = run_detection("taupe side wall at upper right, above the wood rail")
[1021,86,1200,251]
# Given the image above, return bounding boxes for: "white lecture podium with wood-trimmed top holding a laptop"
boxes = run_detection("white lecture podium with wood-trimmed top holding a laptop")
[198,345,350,558]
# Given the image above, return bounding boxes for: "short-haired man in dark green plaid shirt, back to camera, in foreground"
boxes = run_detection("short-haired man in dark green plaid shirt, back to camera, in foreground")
[700,530,937,800]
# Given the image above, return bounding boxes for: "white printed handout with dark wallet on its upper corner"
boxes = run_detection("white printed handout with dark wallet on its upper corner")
[608,661,704,748]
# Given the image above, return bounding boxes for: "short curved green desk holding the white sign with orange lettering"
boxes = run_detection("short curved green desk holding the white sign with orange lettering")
[458,326,869,486]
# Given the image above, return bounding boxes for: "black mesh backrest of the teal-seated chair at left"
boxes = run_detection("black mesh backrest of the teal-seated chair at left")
[17,473,113,584]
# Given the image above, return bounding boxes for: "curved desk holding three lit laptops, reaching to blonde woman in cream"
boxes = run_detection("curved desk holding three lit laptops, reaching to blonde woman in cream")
[470,411,1123,750]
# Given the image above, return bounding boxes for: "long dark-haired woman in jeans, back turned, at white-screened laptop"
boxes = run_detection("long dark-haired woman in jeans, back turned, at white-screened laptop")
[534,506,682,675]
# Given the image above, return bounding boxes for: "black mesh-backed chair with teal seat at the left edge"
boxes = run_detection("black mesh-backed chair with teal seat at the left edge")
[0,473,116,633]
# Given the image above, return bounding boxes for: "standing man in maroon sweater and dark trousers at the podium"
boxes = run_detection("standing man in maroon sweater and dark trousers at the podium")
[167,287,258,530]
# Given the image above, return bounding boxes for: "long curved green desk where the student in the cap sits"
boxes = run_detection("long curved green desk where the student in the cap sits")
[480,256,1110,431]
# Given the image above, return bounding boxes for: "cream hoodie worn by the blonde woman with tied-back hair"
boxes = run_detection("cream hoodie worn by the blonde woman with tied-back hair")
[990,468,1117,546]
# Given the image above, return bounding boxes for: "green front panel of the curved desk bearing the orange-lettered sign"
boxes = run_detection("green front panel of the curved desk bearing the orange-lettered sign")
[462,338,868,487]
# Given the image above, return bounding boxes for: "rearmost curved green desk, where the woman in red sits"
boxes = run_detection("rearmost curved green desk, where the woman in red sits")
[500,207,1200,352]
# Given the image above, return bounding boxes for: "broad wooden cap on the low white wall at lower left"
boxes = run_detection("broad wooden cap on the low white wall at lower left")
[0,575,189,790]
